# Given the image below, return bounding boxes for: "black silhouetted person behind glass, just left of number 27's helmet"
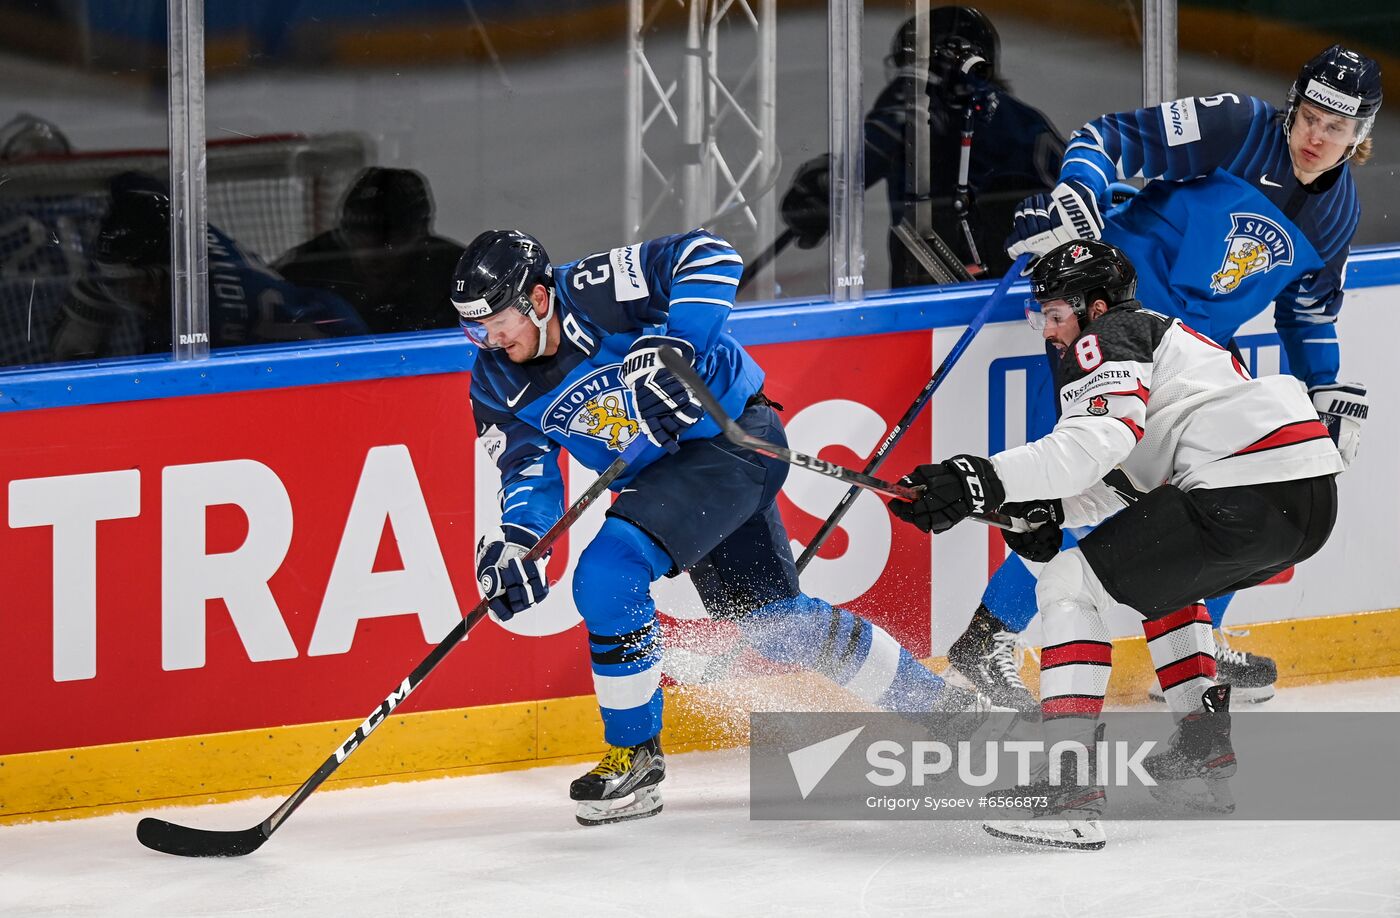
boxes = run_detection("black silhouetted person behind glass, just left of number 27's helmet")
[274,167,462,334]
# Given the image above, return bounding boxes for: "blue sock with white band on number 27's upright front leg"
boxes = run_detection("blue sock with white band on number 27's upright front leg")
[574,516,671,746]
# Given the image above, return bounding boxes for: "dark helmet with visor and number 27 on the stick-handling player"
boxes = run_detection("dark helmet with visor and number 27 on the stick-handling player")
[452,230,554,357]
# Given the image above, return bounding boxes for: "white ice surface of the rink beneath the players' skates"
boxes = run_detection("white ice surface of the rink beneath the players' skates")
[8,679,1400,918]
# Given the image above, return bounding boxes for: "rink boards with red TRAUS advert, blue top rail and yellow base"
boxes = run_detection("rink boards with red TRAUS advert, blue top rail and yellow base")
[0,252,1400,820]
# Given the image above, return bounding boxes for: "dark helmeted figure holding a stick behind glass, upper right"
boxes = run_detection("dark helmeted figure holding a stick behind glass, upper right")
[783,6,1064,287]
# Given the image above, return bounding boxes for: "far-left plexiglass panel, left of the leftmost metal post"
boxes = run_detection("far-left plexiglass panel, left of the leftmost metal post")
[0,0,171,367]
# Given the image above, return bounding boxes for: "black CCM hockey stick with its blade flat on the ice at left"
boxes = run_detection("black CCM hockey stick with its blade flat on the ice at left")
[136,437,650,858]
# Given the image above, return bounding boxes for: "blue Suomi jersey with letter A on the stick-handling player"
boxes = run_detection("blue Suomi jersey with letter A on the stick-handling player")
[472,230,763,535]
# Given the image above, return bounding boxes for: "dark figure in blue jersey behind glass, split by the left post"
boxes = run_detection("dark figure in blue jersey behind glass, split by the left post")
[50,172,367,361]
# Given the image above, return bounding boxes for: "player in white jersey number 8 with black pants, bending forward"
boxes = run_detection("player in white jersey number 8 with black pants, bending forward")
[890,239,1343,848]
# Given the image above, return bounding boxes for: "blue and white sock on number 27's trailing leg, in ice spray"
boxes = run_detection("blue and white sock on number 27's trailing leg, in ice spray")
[739,595,944,714]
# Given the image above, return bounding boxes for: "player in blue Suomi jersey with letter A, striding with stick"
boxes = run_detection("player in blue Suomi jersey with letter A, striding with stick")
[452,230,988,826]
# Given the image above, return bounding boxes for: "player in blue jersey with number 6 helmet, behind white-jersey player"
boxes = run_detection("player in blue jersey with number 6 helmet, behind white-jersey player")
[949,45,1382,709]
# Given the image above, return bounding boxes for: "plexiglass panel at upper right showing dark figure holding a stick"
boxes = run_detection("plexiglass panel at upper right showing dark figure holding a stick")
[864,3,1142,291]
